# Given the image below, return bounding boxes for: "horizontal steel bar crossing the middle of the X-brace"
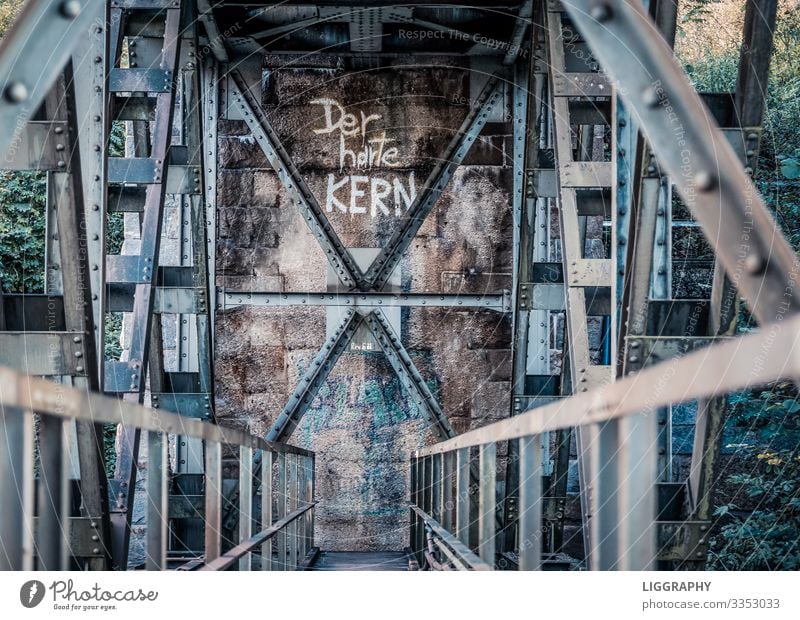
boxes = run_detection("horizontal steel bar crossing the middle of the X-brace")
[217,289,511,312]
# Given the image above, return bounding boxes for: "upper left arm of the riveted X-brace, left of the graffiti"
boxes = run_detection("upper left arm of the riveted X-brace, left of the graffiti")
[229,71,365,288]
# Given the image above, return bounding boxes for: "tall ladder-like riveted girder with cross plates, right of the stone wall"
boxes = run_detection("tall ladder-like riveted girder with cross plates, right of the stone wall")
[546,5,617,567]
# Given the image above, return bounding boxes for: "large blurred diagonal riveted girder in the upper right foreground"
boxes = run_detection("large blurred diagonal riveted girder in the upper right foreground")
[563,0,798,324]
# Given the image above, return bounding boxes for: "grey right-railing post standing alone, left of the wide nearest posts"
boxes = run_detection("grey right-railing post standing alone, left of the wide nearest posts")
[518,435,546,570]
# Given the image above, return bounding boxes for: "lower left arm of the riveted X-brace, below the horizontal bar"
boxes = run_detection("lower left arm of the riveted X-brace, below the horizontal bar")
[267,310,362,441]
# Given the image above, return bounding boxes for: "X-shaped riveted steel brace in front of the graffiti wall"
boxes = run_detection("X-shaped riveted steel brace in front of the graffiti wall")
[230,65,502,441]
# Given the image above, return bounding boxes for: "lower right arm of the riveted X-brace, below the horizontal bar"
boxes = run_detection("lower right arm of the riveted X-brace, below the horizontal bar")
[364,310,455,440]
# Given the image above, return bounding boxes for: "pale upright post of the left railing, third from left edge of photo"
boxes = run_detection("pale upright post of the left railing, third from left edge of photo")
[145,431,169,570]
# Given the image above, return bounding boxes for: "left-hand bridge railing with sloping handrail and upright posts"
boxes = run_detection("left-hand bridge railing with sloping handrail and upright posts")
[0,367,315,570]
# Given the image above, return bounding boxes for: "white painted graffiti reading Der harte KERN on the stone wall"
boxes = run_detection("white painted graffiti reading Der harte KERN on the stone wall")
[311,98,417,218]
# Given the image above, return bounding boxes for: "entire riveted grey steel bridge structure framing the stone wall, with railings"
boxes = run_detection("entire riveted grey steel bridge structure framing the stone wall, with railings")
[0,0,800,570]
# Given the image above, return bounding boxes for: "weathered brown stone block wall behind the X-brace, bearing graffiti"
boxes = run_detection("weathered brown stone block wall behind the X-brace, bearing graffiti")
[216,56,512,550]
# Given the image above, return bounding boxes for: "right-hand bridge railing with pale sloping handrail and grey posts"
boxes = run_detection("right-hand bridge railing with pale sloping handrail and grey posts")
[410,317,800,570]
